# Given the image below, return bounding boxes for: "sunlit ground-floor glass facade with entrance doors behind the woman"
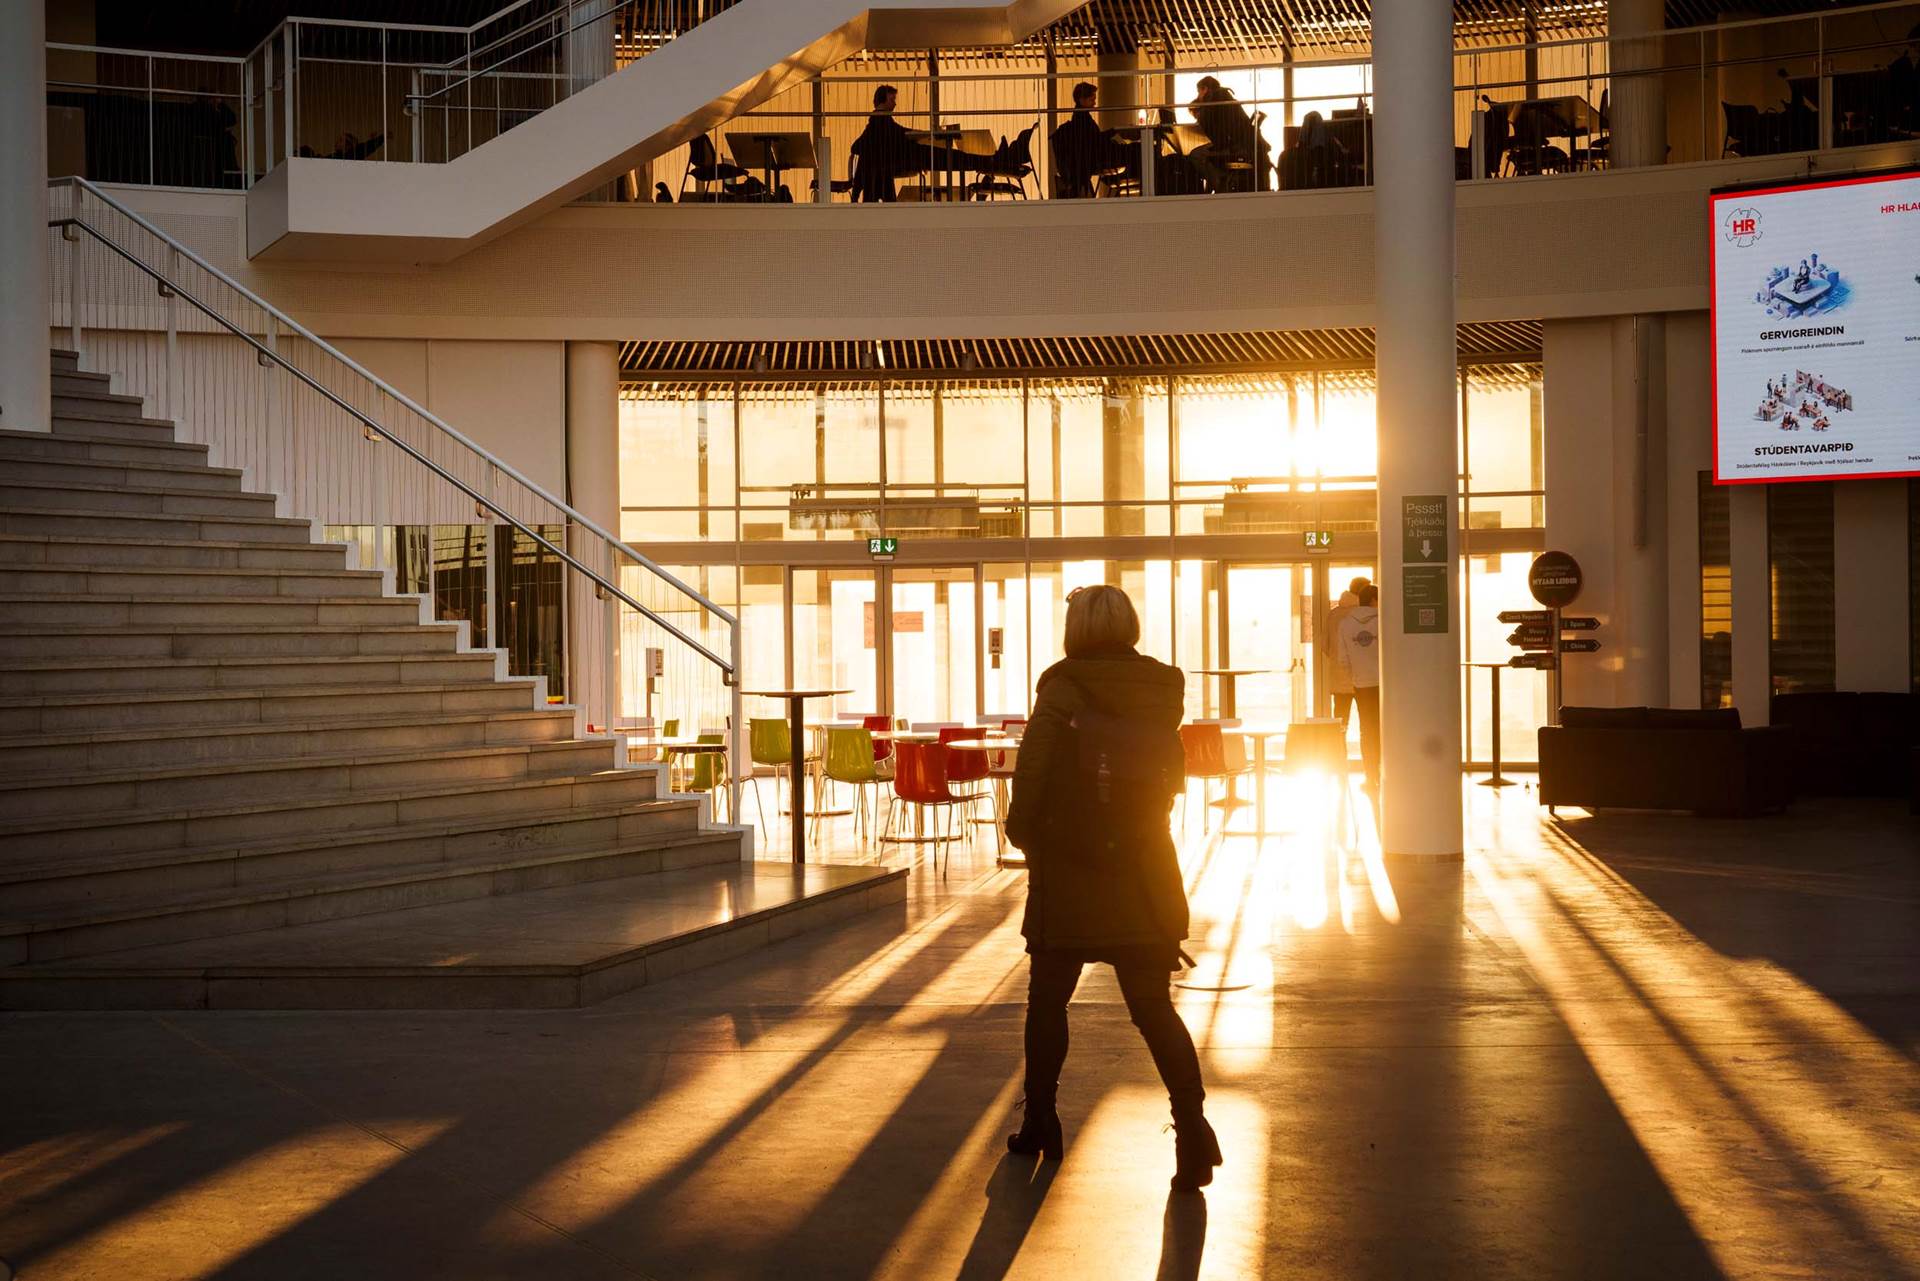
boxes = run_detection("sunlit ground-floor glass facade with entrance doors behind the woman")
[620,363,1548,761]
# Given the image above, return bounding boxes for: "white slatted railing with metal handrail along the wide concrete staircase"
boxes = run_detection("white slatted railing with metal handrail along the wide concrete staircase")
[48,177,745,816]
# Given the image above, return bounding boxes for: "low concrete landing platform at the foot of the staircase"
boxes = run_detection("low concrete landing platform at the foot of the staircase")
[0,862,906,1010]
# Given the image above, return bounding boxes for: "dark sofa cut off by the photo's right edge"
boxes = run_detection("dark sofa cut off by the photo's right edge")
[1772,691,1920,805]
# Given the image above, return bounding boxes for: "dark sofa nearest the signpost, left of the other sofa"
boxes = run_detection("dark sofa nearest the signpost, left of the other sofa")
[1540,707,1793,816]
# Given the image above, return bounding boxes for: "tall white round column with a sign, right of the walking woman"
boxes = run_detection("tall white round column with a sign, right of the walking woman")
[1373,0,1463,858]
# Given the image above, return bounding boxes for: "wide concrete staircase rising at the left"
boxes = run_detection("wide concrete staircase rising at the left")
[0,351,904,1008]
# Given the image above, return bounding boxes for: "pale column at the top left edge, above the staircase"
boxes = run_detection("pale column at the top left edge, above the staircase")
[0,0,54,432]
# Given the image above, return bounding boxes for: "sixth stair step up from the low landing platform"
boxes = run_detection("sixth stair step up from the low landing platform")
[0,676,543,736]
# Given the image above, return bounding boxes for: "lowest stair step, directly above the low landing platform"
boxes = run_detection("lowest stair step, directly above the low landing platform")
[0,799,721,964]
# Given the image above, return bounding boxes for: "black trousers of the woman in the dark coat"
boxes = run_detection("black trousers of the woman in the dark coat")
[1027,953,1206,1116]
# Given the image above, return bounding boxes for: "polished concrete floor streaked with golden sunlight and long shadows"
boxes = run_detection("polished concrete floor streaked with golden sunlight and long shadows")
[0,784,1920,1281]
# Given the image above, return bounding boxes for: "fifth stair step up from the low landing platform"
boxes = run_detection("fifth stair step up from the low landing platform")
[0,709,574,776]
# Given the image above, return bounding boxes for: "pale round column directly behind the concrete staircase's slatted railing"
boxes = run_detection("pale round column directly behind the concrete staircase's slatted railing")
[566,342,622,730]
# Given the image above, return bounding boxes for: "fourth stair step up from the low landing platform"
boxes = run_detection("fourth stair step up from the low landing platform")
[0,737,614,822]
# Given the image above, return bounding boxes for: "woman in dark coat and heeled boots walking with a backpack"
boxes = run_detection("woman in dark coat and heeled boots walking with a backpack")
[1006,586,1221,1191]
